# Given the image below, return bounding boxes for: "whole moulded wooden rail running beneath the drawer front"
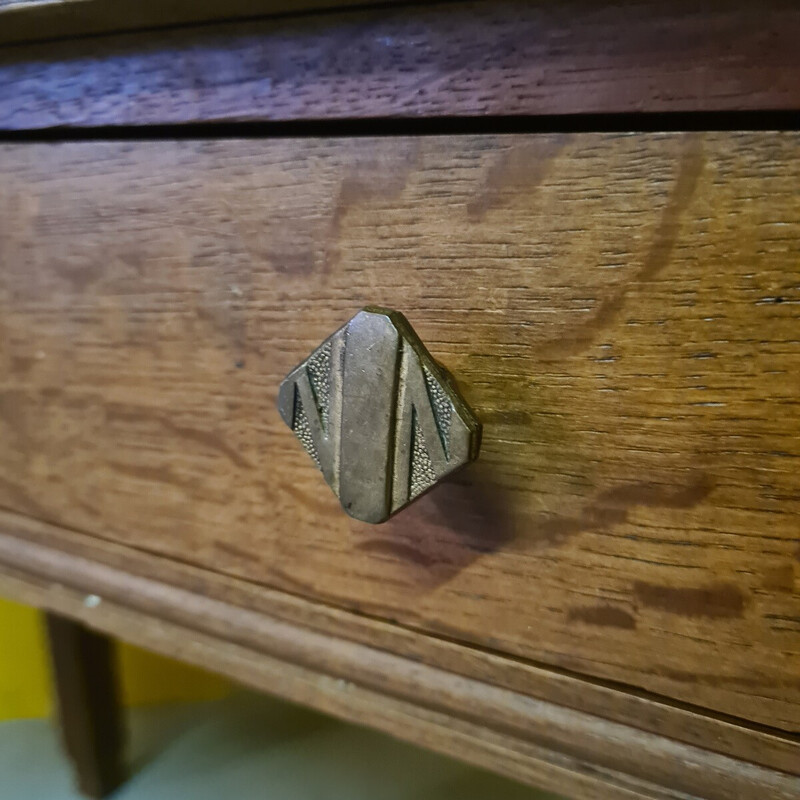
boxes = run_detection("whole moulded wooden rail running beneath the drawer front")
[0,515,800,800]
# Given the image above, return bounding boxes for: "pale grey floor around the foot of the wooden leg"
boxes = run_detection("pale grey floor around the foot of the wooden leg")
[0,692,558,800]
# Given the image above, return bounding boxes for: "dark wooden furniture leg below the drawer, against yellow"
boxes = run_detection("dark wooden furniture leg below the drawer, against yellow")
[45,614,125,798]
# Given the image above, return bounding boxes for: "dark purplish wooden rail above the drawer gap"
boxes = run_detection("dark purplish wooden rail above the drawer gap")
[0,0,800,130]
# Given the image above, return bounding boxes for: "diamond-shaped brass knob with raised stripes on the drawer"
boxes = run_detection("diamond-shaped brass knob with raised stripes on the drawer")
[278,307,481,522]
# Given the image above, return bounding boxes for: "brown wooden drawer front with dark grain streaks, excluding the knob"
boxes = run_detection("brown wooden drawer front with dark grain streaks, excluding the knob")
[0,133,800,729]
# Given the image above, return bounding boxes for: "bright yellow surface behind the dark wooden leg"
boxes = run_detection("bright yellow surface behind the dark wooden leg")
[0,598,230,720]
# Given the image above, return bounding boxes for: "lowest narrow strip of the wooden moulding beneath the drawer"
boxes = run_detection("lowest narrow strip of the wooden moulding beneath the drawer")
[0,572,712,800]
